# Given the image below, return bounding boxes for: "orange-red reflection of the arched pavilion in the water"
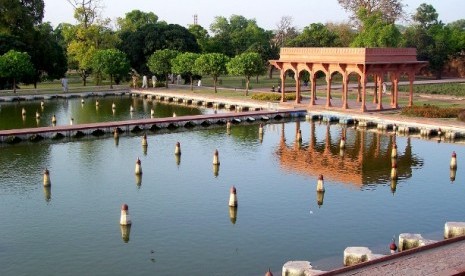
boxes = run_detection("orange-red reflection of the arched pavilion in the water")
[276,121,423,189]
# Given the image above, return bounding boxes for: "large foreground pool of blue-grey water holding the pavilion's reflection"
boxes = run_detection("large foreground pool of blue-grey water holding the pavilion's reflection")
[0,119,465,275]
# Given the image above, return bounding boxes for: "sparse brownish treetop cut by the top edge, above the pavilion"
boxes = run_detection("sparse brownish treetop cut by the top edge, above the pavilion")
[338,0,405,23]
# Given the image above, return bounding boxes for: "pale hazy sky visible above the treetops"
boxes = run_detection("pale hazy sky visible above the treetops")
[44,0,465,30]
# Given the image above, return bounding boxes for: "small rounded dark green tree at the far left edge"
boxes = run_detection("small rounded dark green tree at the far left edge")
[0,50,34,93]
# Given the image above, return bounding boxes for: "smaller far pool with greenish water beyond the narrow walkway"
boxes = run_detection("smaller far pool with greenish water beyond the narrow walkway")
[0,95,225,130]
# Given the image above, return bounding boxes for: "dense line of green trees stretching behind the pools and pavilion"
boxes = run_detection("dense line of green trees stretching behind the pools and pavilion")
[0,0,465,91]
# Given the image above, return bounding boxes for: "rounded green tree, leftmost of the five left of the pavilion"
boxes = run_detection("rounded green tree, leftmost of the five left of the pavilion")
[92,49,130,89]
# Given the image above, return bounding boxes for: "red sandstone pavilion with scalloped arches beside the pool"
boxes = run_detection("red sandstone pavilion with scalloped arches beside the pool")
[270,48,427,112]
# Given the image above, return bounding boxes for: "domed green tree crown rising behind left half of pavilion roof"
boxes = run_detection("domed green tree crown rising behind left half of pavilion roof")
[288,23,338,47]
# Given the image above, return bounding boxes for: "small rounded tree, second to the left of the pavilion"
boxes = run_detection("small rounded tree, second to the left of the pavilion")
[195,53,229,93]
